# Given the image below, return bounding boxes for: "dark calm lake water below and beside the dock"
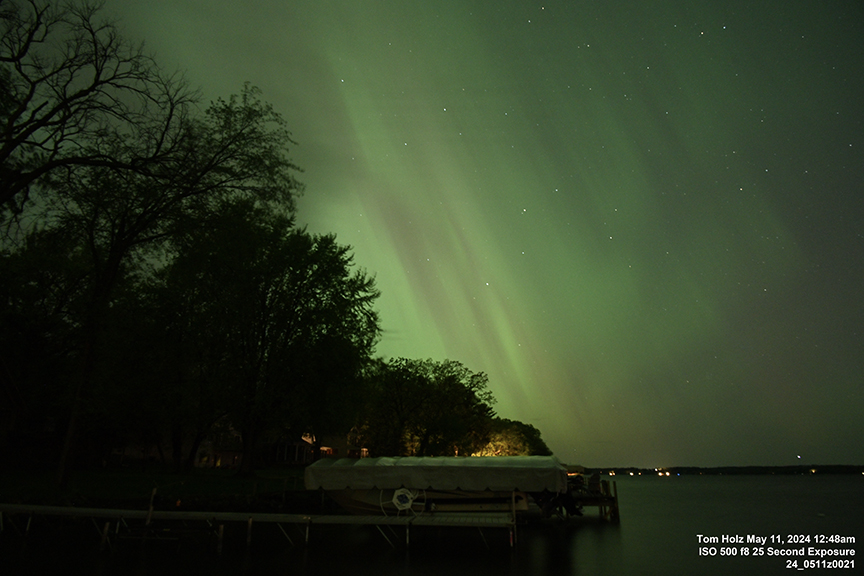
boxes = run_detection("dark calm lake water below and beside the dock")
[0,474,864,576]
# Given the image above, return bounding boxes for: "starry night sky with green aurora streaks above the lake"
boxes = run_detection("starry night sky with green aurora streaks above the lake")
[105,0,864,467]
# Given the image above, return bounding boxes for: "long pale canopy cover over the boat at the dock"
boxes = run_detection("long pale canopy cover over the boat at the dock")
[305,456,567,492]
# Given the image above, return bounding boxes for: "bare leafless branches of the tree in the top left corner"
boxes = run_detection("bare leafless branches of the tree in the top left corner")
[0,0,194,211]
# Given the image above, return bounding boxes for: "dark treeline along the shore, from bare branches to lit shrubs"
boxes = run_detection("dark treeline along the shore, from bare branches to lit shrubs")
[0,0,549,480]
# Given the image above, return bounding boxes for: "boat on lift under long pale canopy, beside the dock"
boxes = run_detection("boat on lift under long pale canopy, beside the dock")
[305,456,568,514]
